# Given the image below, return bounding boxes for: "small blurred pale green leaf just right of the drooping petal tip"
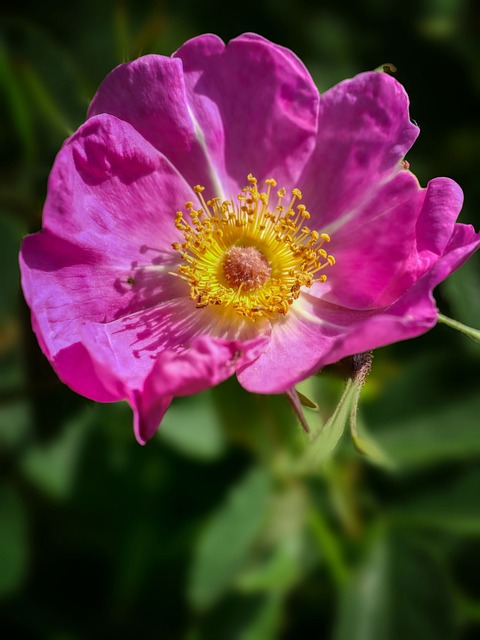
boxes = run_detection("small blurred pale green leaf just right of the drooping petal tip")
[158,391,226,460]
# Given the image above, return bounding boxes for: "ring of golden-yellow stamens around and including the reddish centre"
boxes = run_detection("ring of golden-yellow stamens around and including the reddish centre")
[172,174,335,321]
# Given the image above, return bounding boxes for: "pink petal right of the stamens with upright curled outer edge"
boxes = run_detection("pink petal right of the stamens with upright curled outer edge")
[314,171,463,309]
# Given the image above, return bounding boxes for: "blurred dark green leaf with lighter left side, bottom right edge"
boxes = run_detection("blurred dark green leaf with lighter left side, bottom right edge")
[333,531,457,640]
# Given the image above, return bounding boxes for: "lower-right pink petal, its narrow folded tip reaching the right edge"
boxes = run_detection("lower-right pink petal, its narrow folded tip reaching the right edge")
[238,225,480,393]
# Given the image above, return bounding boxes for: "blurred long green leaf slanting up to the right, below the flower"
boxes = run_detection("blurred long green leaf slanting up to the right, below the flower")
[188,468,270,609]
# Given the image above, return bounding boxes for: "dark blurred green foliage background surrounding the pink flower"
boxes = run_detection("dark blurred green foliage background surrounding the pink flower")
[0,0,480,640]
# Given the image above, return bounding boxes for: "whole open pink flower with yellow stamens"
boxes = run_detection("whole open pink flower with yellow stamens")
[21,34,480,443]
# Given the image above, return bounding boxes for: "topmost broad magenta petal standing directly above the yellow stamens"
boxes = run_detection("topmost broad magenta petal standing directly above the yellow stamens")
[174,34,318,196]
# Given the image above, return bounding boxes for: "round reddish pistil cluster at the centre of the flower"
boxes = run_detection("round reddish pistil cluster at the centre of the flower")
[223,247,272,291]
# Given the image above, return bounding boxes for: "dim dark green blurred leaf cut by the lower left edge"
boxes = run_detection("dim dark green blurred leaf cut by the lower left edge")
[0,486,28,597]
